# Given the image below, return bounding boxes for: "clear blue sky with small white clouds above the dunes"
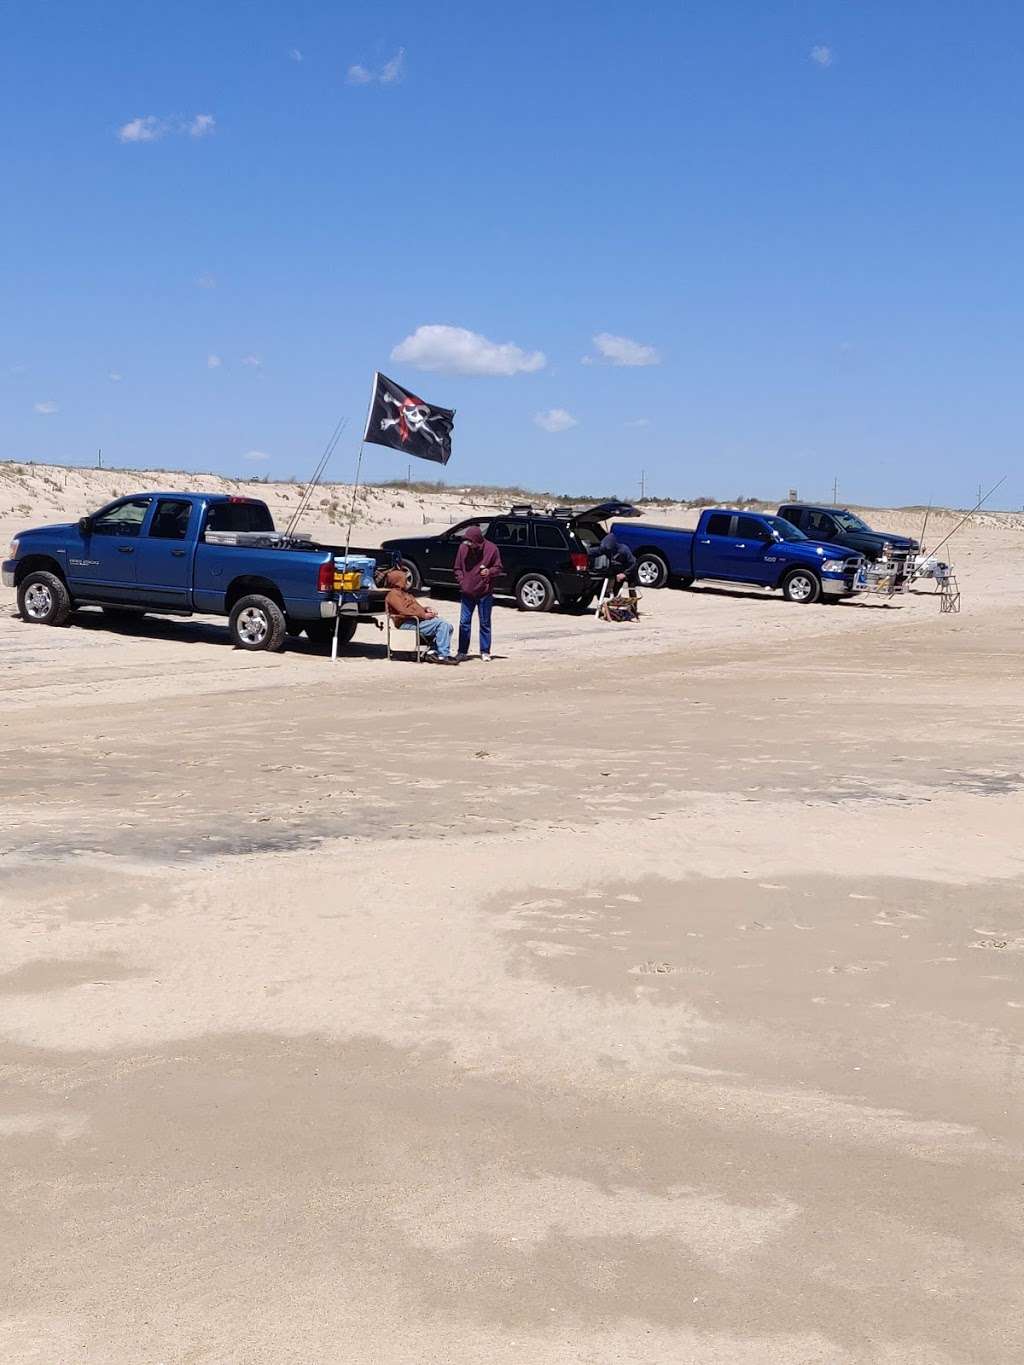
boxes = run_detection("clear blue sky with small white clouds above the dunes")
[0,0,1024,506]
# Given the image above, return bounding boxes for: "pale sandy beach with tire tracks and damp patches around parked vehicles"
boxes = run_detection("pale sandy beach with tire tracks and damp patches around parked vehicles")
[0,465,1024,1365]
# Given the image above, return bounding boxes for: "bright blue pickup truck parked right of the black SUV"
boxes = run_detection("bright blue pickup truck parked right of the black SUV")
[612,508,863,602]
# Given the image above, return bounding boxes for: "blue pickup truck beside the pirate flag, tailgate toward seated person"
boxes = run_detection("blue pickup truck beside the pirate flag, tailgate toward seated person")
[0,493,396,650]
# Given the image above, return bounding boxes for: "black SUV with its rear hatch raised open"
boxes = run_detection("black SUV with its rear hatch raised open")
[382,501,640,612]
